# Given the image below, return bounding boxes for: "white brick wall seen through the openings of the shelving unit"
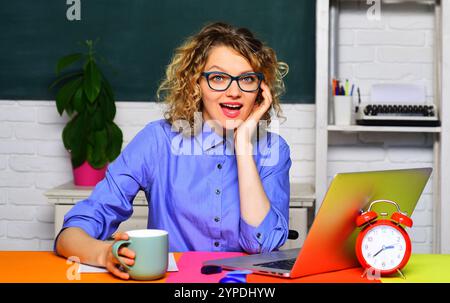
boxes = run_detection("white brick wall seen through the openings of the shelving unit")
[334,1,434,253]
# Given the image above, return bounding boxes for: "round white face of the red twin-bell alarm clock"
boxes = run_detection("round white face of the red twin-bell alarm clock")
[361,225,406,270]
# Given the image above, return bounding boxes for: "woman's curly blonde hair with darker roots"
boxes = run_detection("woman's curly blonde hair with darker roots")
[157,22,289,135]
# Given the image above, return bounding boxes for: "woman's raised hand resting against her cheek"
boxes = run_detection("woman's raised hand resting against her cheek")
[234,81,273,155]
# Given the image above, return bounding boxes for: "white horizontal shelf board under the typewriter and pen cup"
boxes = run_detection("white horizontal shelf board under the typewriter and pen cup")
[327,125,441,133]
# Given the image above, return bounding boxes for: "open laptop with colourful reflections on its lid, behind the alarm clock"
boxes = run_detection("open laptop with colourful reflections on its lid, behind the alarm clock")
[203,167,432,278]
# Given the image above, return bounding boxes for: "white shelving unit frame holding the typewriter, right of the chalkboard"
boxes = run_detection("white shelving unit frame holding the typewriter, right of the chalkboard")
[315,0,450,253]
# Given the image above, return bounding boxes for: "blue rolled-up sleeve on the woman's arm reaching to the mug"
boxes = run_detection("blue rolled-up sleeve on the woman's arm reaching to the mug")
[55,126,156,252]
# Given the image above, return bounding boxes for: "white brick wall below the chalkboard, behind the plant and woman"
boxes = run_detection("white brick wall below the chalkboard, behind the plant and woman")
[0,100,315,250]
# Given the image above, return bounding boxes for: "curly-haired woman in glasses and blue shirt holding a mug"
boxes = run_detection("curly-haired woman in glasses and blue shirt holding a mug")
[55,23,291,279]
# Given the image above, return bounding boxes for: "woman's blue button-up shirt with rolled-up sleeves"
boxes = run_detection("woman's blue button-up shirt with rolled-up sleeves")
[59,120,291,253]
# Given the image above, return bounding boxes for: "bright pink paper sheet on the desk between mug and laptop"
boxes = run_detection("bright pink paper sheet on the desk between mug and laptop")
[166,251,245,283]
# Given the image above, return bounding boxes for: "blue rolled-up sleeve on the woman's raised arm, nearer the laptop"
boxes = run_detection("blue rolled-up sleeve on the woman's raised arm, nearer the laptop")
[239,136,292,253]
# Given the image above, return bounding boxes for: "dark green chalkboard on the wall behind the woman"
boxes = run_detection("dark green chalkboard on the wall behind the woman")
[0,0,315,103]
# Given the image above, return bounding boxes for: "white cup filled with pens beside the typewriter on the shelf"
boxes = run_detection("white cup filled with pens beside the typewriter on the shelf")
[333,79,355,125]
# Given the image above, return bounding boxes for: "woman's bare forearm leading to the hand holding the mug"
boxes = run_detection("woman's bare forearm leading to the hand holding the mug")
[56,227,111,266]
